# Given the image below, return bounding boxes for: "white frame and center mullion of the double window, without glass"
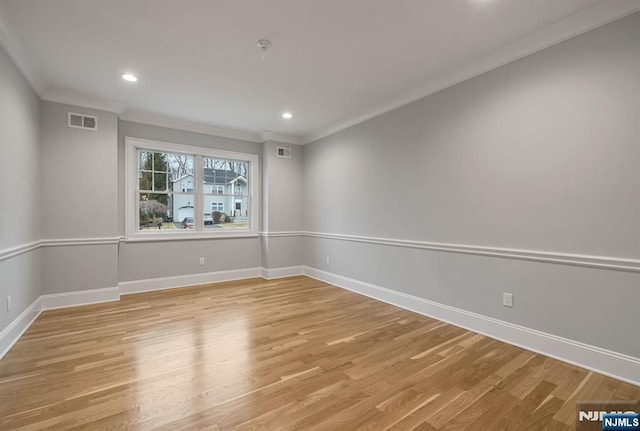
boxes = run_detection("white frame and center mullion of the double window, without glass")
[125,137,260,241]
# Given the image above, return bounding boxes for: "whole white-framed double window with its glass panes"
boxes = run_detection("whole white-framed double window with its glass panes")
[125,138,258,240]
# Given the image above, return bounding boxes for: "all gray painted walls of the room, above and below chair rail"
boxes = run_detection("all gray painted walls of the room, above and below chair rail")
[0,7,640,364]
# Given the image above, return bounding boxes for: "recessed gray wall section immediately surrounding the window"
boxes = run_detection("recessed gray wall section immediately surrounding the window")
[118,121,261,281]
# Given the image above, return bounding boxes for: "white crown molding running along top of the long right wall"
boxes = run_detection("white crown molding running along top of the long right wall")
[302,0,640,145]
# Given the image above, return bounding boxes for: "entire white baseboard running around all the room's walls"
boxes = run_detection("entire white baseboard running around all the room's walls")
[8,266,640,386]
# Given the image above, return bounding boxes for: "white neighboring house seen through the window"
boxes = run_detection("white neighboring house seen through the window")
[169,169,247,222]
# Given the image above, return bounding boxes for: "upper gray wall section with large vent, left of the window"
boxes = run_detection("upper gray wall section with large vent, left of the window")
[41,102,118,239]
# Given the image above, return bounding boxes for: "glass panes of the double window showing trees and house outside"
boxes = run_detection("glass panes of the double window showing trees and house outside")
[127,144,255,234]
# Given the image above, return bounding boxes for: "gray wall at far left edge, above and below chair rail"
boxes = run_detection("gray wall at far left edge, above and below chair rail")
[0,47,42,331]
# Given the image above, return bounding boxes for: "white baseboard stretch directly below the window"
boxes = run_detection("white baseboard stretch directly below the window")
[118,268,263,295]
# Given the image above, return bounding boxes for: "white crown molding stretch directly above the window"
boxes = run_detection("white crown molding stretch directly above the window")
[120,110,261,143]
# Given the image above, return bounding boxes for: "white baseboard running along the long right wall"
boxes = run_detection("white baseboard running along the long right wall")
[304,266,640,386]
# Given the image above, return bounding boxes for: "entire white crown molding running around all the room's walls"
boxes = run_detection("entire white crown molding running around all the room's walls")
[0,0,640,145]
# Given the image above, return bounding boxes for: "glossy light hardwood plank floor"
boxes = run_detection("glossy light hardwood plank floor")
[0,277,640,431]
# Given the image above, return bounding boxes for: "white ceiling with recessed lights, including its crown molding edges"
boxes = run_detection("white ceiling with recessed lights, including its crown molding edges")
[0,0,640,142]
